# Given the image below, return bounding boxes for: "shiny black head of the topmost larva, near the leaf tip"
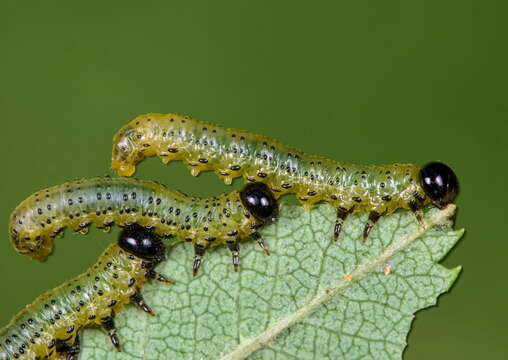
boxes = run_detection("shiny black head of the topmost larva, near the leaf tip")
[421,162,459,209]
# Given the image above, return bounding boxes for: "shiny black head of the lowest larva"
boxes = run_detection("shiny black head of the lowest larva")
[118,224,165,261]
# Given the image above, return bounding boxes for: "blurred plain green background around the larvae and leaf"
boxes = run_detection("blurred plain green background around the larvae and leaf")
[0,0,508,359]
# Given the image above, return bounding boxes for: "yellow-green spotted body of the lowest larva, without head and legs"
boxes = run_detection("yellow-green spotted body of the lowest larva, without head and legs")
[0,243,147,360]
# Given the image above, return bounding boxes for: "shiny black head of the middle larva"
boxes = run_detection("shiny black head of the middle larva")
[240,183,279,222]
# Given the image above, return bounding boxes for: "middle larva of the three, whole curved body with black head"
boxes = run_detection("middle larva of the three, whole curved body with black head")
[9,177,278,275]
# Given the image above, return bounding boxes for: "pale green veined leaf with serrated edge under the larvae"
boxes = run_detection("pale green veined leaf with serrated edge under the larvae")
[81,205,463,360]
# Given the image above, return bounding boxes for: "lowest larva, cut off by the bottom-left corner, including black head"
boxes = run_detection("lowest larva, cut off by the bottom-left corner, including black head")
[0,225,172,360]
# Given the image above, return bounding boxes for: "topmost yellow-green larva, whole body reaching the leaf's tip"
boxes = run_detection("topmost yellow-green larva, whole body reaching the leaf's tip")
[112,114,458,240]
